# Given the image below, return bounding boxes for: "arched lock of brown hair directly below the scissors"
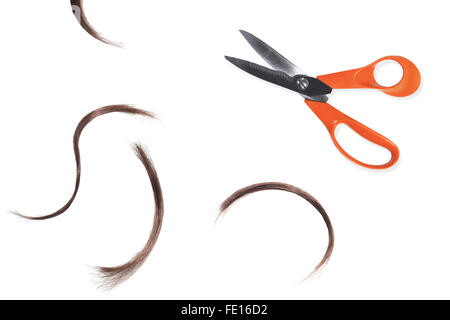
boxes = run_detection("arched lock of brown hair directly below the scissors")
[218,182,334,278]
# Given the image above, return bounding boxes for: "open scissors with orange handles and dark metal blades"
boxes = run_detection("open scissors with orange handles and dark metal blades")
[225,30,421,169]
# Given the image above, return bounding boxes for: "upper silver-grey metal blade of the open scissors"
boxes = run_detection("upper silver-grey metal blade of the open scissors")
[239,30,306,77]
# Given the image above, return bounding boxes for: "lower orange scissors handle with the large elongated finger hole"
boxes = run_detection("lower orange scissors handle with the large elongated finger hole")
[305,100,400,169]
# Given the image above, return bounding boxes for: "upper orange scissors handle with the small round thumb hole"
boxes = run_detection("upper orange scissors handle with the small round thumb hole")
[317,56,421,97]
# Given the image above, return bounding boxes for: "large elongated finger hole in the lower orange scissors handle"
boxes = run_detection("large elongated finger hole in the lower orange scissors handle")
[334,124,392,165]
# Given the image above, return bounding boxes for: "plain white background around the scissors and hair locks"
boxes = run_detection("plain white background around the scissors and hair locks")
[0,0,450,299]
